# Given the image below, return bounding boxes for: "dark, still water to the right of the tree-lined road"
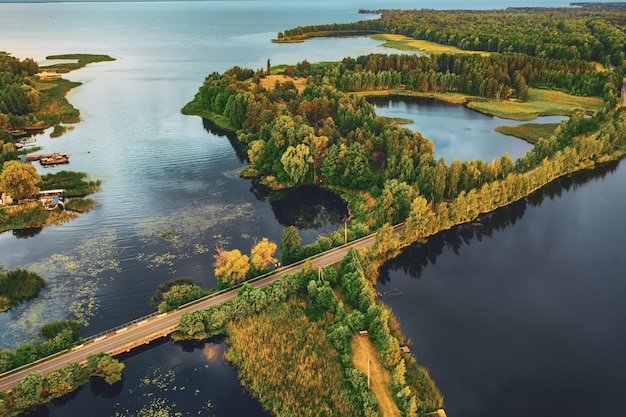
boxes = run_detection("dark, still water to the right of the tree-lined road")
[377,162,626,417]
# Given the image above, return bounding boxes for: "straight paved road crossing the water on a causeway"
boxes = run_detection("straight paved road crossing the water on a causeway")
[0,226,400,390]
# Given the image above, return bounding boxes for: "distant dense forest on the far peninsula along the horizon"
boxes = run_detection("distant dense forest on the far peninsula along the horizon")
[278,8,626,66]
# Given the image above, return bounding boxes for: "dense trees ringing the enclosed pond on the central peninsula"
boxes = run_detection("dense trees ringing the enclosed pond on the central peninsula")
[183,54,624,225]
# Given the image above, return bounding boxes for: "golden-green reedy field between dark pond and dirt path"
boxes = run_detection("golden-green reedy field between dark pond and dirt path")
[224,299,358,417]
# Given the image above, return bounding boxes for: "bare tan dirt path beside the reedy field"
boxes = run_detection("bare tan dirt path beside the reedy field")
[352,334,401,417]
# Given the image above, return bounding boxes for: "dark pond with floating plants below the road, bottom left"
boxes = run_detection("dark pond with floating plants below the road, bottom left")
[21,337,270,417]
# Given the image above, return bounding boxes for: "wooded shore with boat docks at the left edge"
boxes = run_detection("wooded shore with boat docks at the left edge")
[0,52,114,232]
